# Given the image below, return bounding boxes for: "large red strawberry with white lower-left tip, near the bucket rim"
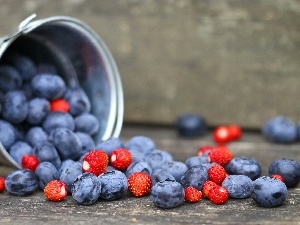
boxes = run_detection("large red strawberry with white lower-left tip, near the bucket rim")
[82,149,108,176]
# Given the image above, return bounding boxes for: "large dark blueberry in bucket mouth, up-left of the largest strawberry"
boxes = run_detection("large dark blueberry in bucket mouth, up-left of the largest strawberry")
[49,128,82,160]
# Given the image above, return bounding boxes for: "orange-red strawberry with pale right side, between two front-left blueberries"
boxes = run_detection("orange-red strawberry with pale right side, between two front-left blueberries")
[44,180,68,202]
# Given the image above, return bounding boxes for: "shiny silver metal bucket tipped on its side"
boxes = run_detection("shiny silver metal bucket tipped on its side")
[0,14,124,168]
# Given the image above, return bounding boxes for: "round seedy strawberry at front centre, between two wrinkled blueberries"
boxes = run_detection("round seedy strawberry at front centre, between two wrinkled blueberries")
[128,172,152,197]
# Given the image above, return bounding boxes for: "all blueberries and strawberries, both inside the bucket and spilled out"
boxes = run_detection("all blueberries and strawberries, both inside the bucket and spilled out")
[0,53,300,211]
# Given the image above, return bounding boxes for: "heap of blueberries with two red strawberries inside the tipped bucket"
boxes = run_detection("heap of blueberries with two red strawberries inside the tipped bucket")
[0,52,99,172]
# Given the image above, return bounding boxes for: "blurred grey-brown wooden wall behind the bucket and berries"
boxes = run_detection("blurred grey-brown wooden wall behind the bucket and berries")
[0,0,300,129]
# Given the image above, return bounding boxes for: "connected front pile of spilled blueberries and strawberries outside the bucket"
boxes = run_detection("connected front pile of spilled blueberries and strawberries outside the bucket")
[0,129,300,208]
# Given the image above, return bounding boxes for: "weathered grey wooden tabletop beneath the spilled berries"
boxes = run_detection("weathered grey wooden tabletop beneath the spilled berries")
[0,126,300,225]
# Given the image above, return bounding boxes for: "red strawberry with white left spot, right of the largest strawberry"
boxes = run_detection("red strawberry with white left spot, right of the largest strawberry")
[110,148,132,170]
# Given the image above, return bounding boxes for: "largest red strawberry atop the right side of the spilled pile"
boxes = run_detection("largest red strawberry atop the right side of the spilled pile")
[208,145,233,166]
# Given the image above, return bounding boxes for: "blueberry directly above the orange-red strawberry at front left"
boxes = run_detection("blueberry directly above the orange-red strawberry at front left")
[35,162,57,190]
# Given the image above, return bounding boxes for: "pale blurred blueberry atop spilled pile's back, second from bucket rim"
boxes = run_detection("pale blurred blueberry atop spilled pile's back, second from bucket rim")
[126,136,156,155]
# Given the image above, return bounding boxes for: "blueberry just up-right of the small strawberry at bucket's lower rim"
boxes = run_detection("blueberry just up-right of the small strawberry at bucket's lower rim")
[34,141,61,168]
